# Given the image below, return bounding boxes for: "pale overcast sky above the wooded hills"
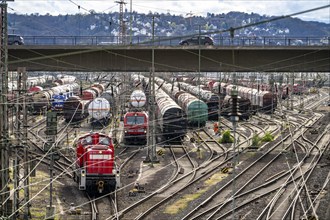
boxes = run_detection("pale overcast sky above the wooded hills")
[7,0,330,24]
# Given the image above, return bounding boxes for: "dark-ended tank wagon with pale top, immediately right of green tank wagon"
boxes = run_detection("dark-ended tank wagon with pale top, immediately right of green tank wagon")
[179,82,219,120]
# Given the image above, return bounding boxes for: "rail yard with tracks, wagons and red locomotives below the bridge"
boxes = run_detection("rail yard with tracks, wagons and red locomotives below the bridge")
[1,73,330,220]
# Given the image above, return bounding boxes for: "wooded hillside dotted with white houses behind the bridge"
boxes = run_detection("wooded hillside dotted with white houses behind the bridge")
[8,12,330,37]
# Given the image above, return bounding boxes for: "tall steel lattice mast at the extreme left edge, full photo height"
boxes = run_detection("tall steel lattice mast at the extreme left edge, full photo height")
[0,0,12,217]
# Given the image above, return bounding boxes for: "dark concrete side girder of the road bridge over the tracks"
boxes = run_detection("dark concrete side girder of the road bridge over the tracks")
[8,46,330,72]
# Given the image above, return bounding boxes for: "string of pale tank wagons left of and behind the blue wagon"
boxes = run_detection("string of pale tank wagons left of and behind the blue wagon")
[31,83,79,113]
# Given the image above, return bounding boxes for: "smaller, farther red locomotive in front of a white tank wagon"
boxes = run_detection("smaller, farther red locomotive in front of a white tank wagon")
[124,111,149,144]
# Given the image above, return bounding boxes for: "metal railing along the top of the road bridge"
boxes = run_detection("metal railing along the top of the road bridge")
[23,36,330,47]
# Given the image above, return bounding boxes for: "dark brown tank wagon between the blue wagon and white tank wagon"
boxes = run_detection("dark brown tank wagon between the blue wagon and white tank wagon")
[63,96,91,122]
